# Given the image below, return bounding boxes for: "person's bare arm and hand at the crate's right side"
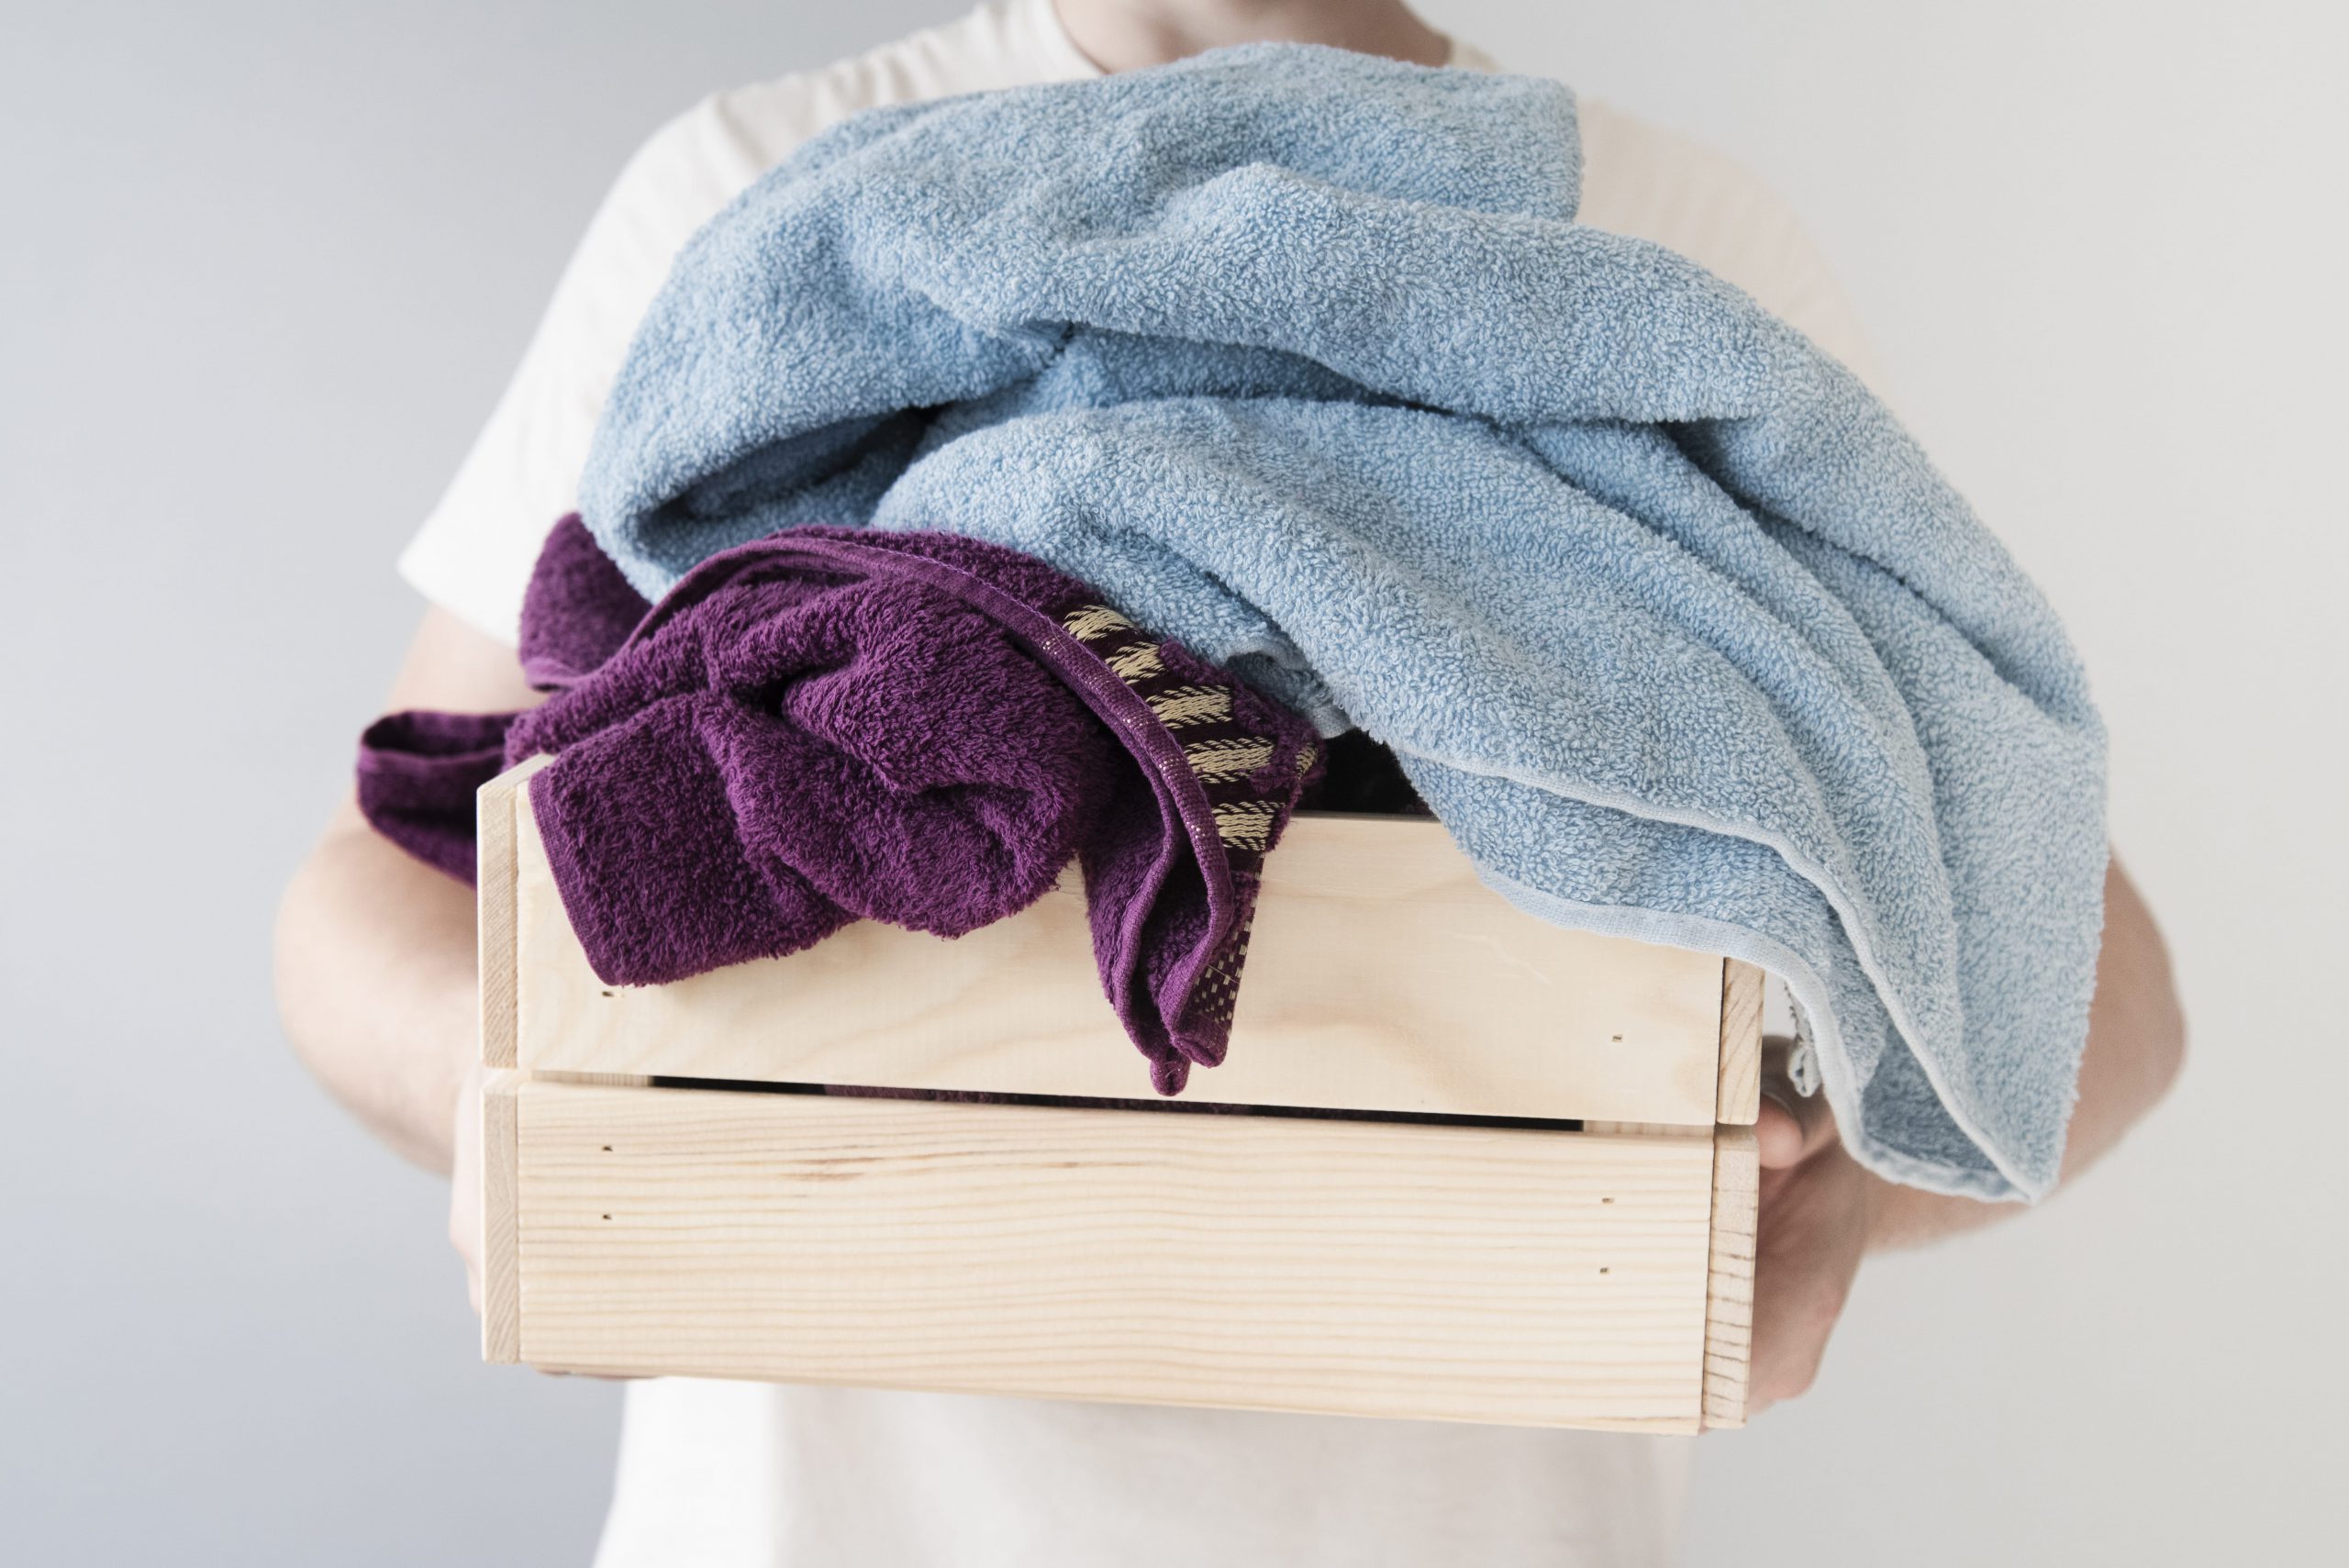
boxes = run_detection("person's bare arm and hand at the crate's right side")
[1748,859,2185,1411]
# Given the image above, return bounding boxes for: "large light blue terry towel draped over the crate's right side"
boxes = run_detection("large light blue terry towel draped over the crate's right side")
[583,45,2105,1197]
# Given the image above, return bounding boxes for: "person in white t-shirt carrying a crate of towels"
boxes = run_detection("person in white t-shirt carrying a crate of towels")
[277,0,2182,1568]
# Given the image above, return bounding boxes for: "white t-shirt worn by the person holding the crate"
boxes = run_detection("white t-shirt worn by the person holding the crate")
[399,0,1875,1568]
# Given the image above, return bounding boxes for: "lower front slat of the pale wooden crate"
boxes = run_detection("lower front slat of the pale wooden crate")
[519,1082,1712,1432]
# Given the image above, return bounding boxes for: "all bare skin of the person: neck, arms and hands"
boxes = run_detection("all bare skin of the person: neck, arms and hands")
[277,0,2185,1411]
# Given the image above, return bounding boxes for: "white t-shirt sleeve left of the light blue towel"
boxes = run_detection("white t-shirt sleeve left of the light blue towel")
[399,98,761,643]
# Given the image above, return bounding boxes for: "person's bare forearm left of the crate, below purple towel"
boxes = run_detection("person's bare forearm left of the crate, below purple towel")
[277,800,477,1172]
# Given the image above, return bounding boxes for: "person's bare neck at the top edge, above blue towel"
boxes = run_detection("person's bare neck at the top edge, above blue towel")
[1052,0,1452,72]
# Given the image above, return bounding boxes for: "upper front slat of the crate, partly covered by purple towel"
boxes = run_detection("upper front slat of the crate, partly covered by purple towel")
[515,765,1721,1127]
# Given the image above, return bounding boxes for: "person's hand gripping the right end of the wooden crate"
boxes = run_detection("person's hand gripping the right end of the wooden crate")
[1745,1047,1879,1416]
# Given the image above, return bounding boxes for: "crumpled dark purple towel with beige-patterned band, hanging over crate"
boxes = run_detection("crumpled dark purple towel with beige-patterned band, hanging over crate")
[360,518,1320,1094]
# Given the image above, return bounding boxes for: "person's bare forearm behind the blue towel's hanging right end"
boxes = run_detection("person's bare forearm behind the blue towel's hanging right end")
[1870,862,2185,1249]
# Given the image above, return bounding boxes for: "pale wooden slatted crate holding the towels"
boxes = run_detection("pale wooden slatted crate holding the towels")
[479,765,1762,1432]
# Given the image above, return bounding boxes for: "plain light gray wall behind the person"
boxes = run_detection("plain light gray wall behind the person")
[0,0,2349,1568]
